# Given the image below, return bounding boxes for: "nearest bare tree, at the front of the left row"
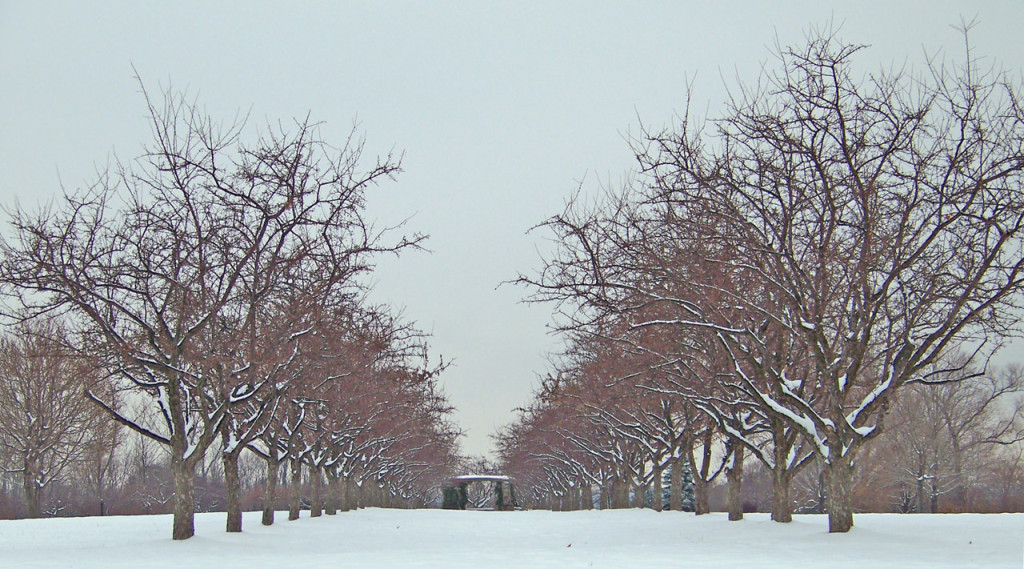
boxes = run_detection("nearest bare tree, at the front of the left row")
[0,83,418,539]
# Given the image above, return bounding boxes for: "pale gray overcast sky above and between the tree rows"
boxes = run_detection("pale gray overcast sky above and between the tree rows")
[0,0,1024,454]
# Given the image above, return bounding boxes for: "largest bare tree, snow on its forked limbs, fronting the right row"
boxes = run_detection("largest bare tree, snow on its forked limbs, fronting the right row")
[524,27,1024,532]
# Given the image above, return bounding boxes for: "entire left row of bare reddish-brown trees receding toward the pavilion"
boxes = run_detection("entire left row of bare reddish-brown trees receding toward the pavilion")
[0,83,457,539]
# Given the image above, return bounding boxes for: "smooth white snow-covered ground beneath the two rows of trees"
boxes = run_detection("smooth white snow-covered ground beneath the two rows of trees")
[0,509,1024,569]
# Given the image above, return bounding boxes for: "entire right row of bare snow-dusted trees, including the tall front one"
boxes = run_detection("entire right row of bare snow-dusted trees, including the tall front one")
[502,31,1024,532]
